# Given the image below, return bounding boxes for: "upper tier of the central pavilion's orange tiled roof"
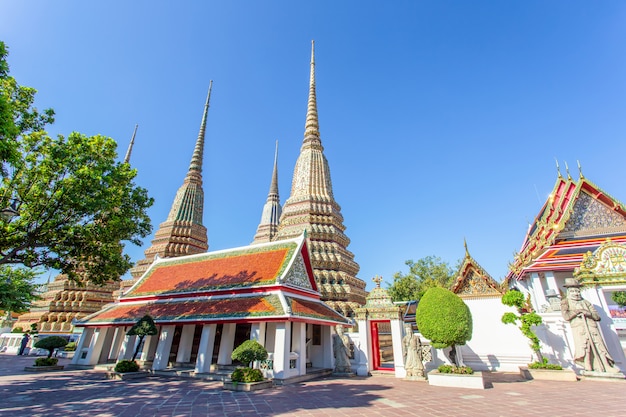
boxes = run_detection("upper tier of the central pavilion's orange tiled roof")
[121,235,317,300]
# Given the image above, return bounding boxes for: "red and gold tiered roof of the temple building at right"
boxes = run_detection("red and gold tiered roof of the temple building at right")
[507,165,626,280]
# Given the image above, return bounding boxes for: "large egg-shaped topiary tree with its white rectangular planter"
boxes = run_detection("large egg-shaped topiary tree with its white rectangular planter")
[415,287,484,389]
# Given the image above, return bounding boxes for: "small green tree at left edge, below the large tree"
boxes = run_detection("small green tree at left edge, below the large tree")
[0,265,40,313]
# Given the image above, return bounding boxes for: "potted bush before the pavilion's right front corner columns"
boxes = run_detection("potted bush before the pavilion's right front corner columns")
[223,340,273,391]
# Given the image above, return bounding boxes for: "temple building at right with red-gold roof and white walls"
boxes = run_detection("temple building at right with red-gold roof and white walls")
[506,166,626,372]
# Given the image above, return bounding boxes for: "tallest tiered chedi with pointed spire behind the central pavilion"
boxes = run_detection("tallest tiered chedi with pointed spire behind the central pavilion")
[273,42,366,317]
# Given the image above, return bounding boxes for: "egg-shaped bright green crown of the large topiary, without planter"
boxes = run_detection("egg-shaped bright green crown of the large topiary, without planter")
[415,287,472,349]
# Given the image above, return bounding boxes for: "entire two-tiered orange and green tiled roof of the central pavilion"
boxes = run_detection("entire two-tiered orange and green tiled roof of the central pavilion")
[77,234,349,326]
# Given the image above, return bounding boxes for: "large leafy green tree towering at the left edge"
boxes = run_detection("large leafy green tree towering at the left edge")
[0,41,153,283]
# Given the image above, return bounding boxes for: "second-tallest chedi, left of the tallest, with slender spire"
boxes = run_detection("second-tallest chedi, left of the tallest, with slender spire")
[123,81,213,282]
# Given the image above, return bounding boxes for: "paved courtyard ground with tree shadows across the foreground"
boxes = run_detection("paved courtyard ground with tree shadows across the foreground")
[0,354,626,417]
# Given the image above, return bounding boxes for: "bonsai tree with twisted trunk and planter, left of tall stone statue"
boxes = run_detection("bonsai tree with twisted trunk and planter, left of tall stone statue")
[502,290,577,381]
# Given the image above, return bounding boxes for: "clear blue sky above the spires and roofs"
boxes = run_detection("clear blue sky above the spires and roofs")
[0,0,626,289]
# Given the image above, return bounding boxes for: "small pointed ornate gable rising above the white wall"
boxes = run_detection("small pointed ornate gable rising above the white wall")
[451,239,502,298]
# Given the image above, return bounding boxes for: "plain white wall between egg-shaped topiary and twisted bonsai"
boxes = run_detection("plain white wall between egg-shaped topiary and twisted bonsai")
[454,297,532,372]
